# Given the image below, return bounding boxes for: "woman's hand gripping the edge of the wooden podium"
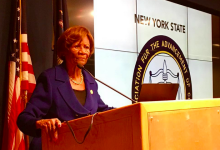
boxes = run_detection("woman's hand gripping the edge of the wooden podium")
[36,118,61,141]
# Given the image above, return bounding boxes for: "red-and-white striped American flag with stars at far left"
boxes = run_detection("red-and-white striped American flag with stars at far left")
[2,0,36,150]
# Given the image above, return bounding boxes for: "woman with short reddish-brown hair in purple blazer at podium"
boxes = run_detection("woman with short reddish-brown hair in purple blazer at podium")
[17,26,112,150]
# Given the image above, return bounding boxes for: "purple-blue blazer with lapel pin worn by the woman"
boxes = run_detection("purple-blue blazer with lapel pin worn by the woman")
[17,64,112,150]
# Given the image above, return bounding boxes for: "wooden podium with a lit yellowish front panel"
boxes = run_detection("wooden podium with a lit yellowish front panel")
[42,99,220,150]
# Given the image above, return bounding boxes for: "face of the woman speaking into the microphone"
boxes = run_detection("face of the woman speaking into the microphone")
[66,36,90,66]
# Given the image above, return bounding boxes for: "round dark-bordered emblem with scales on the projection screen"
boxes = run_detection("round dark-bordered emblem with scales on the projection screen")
[132,35,192,100]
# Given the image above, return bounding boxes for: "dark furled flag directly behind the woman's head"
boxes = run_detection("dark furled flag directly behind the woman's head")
[53,0,69,66]
